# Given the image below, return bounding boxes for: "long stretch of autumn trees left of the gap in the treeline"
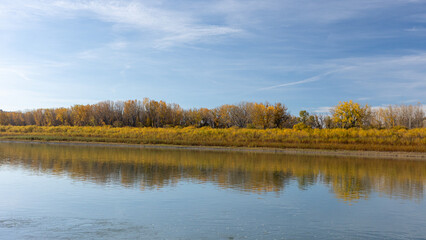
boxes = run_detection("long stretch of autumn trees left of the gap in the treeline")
[0,98,292,128]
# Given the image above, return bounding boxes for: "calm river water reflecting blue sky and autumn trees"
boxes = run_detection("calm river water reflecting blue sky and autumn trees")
[0,143,426,239]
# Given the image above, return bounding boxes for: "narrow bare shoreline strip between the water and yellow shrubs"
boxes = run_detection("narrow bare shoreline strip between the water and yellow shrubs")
[0,140,426,161]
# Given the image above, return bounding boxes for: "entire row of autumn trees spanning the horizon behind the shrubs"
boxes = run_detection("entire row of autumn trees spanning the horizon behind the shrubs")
[0,98,425,129]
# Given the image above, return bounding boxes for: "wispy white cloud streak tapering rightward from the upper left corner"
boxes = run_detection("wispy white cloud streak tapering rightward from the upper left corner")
[0,0,243,48]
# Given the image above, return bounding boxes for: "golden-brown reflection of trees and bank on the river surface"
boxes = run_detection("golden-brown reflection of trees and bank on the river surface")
[0,143,426,202]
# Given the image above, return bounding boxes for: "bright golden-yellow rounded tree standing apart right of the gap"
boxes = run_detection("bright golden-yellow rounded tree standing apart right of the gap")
[331,100,369,128]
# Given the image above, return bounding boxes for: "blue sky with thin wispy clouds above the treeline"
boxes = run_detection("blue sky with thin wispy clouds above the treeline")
[0,0,426,113]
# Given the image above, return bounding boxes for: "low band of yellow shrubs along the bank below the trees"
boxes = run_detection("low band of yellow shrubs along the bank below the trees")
[0,126,426,152]
